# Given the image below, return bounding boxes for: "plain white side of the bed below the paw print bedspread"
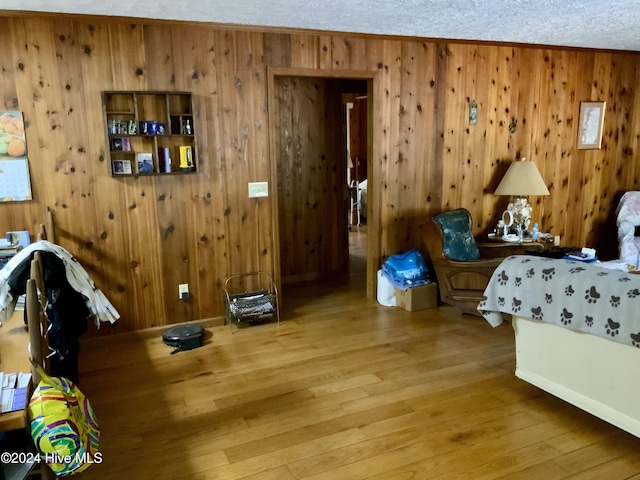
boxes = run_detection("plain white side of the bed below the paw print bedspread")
[512,316,640,437]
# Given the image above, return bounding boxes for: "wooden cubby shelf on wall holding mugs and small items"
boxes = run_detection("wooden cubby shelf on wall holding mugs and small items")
[102,91,197,177]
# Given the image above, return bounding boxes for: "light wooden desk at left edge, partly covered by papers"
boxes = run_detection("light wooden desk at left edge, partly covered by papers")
[0,310,31,432]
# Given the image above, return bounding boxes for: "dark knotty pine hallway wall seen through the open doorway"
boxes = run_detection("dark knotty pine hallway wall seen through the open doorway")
[273,76,348,282]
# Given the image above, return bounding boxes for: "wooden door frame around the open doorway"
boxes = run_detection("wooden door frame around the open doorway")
[267,67,380,299]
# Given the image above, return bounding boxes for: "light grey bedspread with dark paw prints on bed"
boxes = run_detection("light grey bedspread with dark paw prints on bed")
[478,255,640,348]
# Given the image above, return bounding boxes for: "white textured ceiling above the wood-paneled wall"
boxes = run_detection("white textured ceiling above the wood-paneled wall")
[7,0,640,51]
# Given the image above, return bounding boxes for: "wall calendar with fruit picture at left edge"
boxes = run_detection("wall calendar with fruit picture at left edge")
[0,111,33,202]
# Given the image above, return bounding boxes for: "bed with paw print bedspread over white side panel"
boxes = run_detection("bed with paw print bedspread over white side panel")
[478,255,640,437]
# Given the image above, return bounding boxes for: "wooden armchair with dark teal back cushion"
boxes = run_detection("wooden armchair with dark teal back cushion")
[420,208,504,316]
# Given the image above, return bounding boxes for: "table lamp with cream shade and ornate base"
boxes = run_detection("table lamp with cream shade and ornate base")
[495,157,549,231]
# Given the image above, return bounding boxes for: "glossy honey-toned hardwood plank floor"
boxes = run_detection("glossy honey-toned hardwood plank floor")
[78,232,640,480]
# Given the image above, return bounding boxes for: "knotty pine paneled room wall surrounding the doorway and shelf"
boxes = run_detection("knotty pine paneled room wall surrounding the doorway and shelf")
[0,16,640,333]
